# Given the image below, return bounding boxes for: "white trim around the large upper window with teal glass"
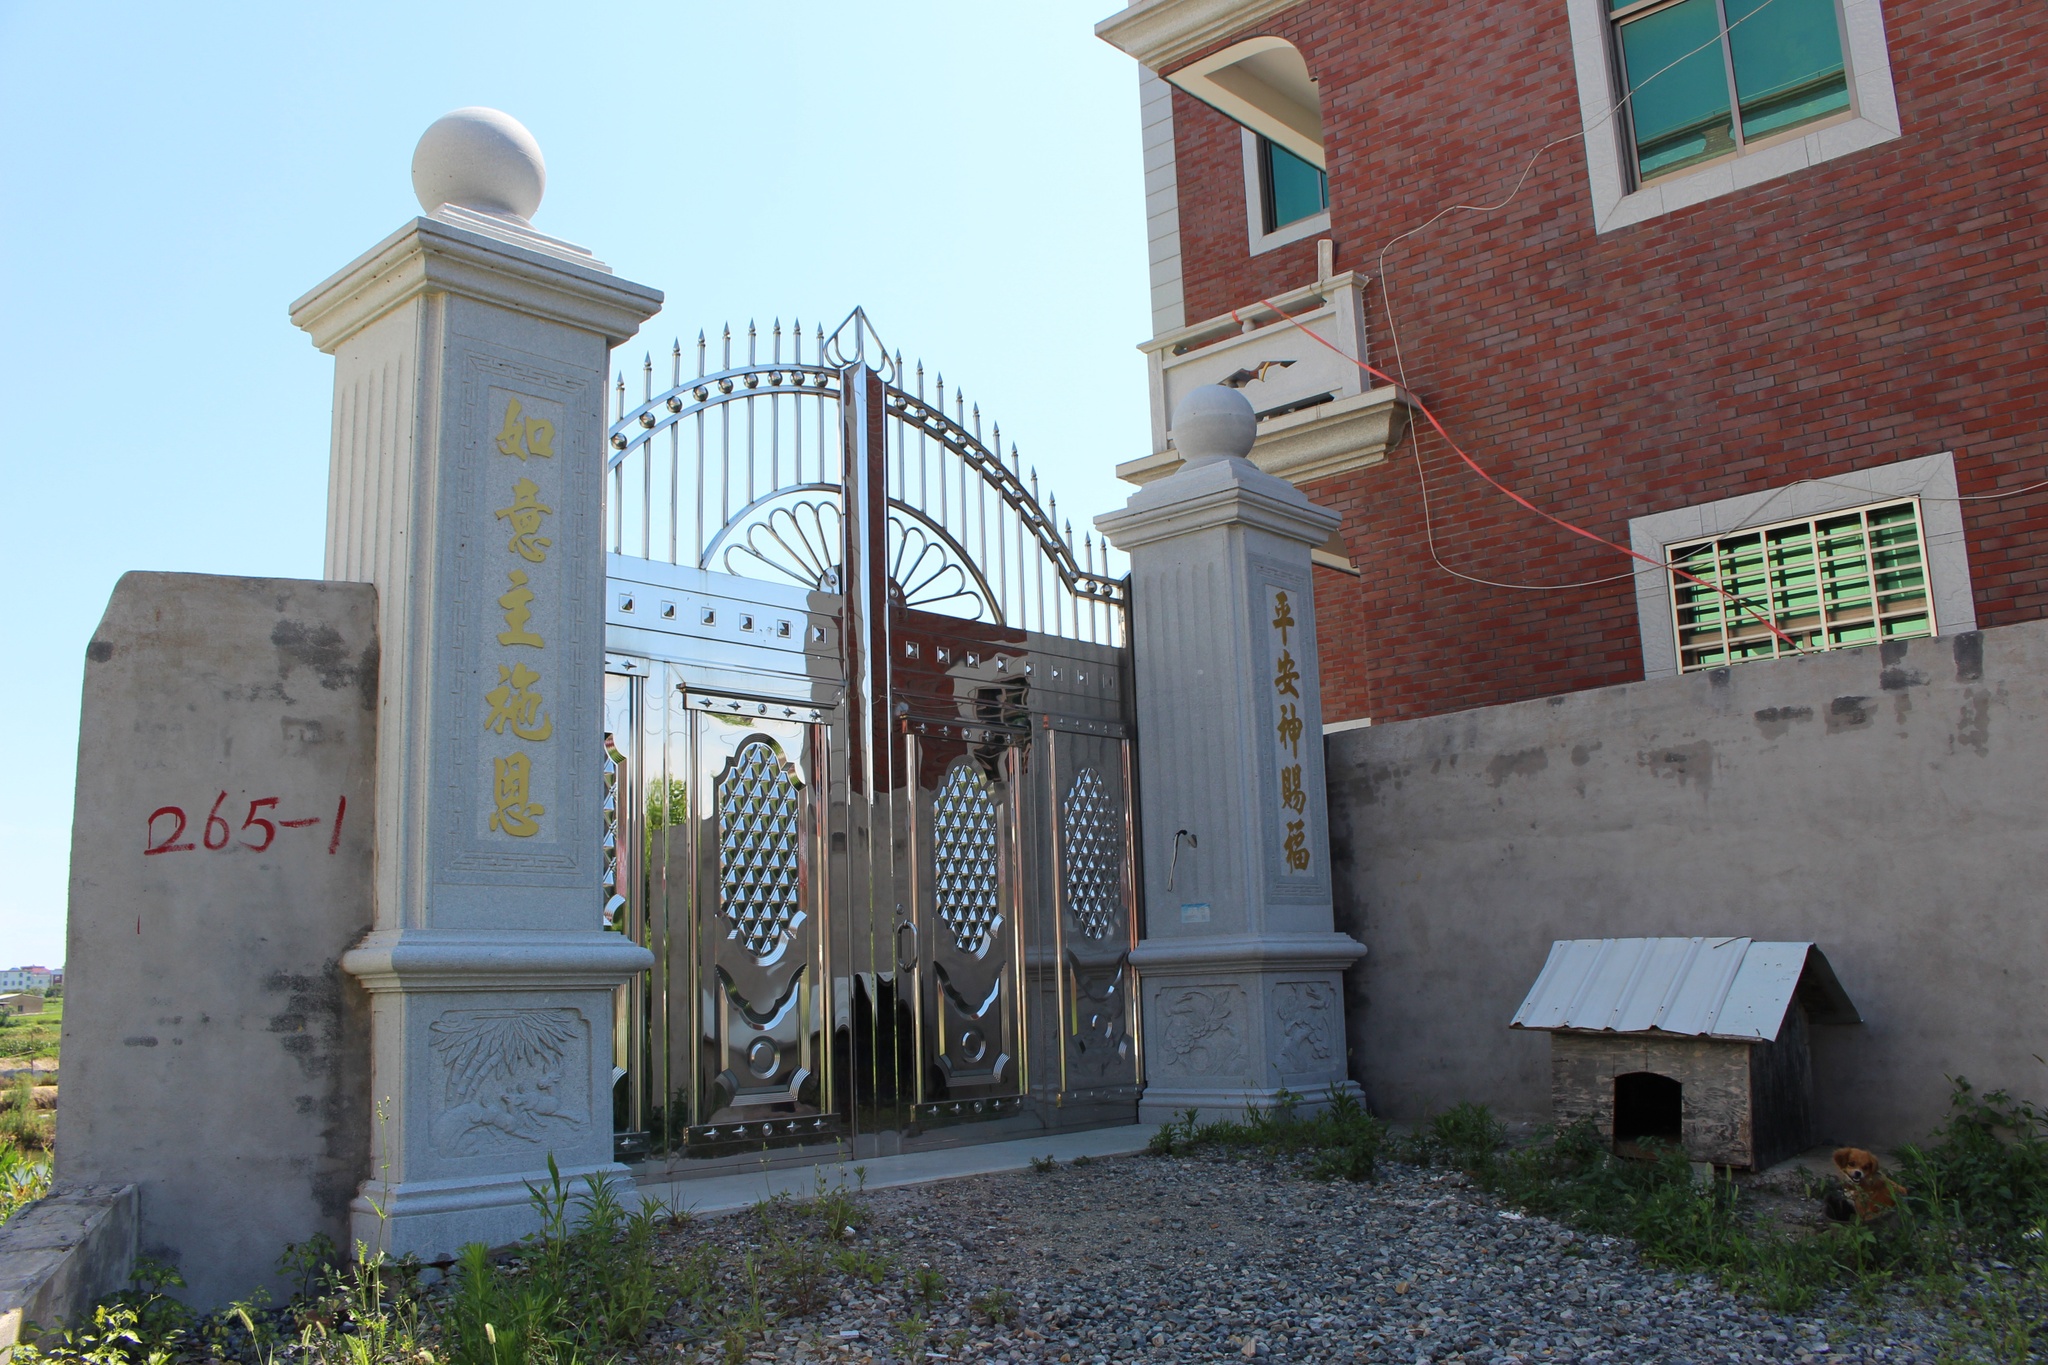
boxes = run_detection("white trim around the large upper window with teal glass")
[1565,0,1898,231]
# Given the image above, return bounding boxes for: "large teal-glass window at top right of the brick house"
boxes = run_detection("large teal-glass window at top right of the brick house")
[1608,0,1849,182]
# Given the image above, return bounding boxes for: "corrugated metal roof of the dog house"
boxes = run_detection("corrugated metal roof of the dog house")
[1509,937,1862,1042]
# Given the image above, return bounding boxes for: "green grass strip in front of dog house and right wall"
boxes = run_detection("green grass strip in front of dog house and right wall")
[1151,1078,2048,1365]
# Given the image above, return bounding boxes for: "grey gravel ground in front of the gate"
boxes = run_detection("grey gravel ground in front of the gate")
[643,1156,1972,1365]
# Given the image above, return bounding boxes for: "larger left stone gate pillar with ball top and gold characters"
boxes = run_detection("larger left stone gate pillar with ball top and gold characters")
[291,108,662,1254]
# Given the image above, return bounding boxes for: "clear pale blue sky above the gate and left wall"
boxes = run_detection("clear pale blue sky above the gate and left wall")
[0,0,1151,966]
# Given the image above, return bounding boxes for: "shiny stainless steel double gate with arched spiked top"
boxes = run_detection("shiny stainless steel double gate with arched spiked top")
[606,311,1143,1158]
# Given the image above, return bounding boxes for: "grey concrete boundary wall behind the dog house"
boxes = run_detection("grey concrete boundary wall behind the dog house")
[1327,622,2048,1146]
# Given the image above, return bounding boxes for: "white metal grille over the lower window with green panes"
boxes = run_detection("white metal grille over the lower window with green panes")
[1665,497,1935,673]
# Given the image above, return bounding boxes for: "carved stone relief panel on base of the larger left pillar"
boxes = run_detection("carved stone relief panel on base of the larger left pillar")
[428,1009,590,1156]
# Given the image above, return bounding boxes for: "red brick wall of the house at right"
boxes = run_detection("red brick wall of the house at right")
[1174,0,2048,720]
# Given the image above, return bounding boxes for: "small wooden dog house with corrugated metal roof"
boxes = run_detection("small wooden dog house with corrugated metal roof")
[1507,937,1862,1169]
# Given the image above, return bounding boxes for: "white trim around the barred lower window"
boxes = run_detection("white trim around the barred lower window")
[1628,450,1976,677]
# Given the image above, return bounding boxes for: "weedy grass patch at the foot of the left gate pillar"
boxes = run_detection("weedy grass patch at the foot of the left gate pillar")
[14,1160,905,1365]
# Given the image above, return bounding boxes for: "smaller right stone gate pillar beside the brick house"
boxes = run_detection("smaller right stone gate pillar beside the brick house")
[1096,385,1364,1121]
